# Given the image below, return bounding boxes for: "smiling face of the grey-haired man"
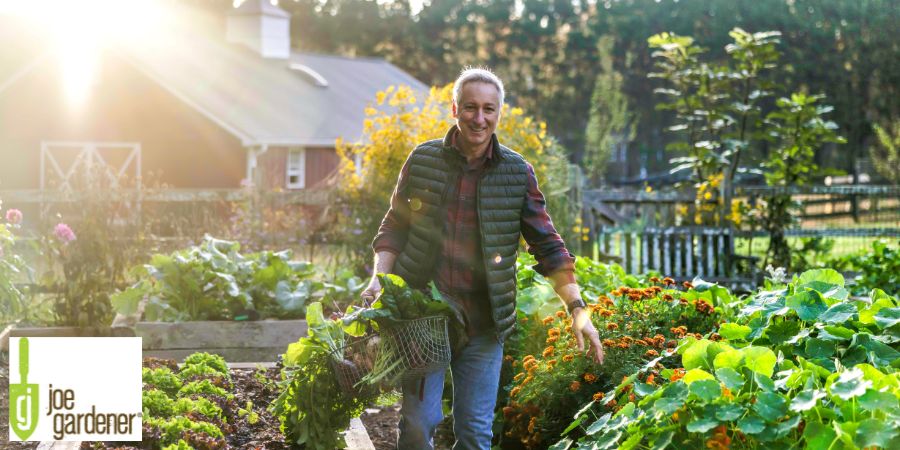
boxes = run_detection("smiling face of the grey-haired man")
[453,81,500,149]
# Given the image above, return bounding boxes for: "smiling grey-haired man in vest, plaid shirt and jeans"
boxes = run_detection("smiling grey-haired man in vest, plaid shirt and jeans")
[362,69,603,450]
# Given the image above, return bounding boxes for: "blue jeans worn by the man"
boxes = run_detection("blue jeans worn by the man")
[397,332,503,450]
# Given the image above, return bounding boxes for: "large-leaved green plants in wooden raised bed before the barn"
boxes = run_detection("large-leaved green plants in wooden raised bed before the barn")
[113,236,362,321]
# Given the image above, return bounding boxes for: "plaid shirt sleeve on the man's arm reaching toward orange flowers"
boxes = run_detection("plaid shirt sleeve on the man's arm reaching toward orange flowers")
[521,164,575,283]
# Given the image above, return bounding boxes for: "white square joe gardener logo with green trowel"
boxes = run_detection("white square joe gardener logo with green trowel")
[9,338,141,441]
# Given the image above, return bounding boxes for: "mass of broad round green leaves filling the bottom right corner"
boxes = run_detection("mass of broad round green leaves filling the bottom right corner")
[553,269,900,450]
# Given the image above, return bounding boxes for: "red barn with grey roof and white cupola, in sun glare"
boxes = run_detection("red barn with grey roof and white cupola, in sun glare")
[0,0,427,197]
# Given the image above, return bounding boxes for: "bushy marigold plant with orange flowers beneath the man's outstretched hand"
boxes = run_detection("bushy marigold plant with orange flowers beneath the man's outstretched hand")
[501,258,728,448]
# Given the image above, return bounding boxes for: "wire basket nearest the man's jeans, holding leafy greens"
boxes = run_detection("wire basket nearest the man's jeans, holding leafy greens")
[382,316,450,383]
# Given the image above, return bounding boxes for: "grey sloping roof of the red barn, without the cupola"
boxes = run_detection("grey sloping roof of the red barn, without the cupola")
[0,14,428,146]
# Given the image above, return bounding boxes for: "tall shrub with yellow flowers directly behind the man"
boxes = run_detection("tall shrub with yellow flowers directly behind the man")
[335,85,580,264]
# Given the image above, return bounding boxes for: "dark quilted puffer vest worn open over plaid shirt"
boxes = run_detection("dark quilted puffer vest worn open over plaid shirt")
[393,129,528,342]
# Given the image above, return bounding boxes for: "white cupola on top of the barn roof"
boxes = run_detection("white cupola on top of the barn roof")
[225,0,291,59]
